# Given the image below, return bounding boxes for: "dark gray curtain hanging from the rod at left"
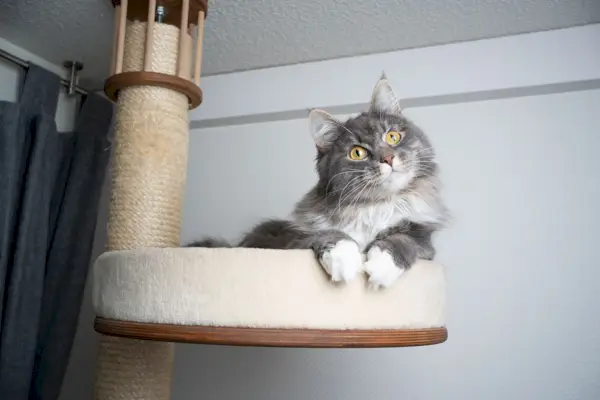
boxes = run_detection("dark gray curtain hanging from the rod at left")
[0,65,113,400]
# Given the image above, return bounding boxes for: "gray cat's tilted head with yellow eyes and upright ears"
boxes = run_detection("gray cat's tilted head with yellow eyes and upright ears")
[309,76,436,201]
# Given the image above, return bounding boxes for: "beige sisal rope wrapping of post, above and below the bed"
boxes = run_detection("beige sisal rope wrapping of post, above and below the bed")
[94,22,188,400]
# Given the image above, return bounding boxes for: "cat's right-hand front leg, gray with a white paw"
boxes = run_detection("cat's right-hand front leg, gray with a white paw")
[365,223,435,289]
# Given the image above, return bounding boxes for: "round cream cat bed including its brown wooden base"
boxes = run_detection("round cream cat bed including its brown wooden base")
[93,248,447,347]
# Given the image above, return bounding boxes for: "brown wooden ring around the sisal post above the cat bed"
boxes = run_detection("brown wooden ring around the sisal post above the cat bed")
[104,71,202,109]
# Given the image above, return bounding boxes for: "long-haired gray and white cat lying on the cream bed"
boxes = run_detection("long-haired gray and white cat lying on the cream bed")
[190,76,447,288]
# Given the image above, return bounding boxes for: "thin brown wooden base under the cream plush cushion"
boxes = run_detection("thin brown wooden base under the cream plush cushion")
[94,318,448,348]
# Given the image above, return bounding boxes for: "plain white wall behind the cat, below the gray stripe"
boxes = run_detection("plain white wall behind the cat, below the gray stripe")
[178,90,600,400]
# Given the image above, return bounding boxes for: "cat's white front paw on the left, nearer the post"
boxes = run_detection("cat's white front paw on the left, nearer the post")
[320,240,363,282]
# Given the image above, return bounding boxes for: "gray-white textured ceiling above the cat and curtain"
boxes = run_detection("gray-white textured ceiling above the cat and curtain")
[0,0,600,84]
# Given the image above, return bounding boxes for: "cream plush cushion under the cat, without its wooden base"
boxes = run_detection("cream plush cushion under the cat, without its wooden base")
[93,248,446,329]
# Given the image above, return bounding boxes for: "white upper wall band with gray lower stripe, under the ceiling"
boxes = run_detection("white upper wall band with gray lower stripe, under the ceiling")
[190,24,600,129]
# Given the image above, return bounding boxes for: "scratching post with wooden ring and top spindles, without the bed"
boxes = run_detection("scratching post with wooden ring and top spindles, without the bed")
[94,0,207,400]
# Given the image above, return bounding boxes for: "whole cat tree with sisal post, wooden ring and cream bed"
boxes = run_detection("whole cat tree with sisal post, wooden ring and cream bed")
[93,0,447,400]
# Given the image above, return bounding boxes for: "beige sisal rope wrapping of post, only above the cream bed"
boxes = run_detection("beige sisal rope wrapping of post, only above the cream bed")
[108,21,189,249]
